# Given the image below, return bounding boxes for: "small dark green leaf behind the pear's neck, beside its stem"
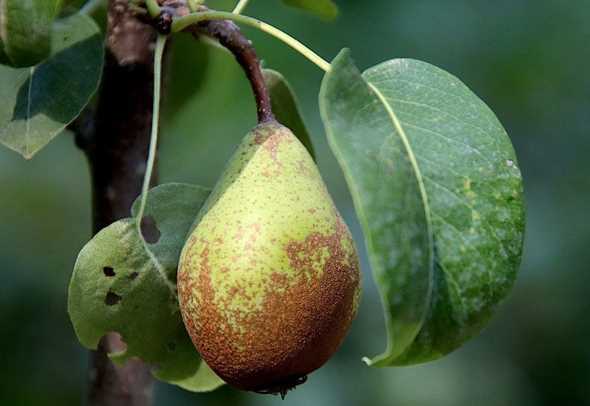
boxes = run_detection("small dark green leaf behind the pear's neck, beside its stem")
[262,69,315,157]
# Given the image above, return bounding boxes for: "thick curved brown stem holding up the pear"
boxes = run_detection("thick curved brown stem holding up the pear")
[193,20,275,123]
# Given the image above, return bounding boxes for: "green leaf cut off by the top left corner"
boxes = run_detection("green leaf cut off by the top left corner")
[0,0,61,68]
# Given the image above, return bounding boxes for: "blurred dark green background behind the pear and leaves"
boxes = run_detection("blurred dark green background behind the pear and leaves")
[0,0,590,406]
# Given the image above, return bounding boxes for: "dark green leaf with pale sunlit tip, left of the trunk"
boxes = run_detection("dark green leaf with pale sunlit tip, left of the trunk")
[0,14,103,159]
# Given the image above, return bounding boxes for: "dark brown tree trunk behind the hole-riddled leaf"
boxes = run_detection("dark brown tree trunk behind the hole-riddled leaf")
[77,0,155,406]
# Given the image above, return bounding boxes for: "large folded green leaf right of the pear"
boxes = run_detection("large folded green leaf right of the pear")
[320,51,524,366]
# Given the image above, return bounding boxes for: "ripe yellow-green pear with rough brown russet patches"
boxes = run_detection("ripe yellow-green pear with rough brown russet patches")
[178,122,360,393]
